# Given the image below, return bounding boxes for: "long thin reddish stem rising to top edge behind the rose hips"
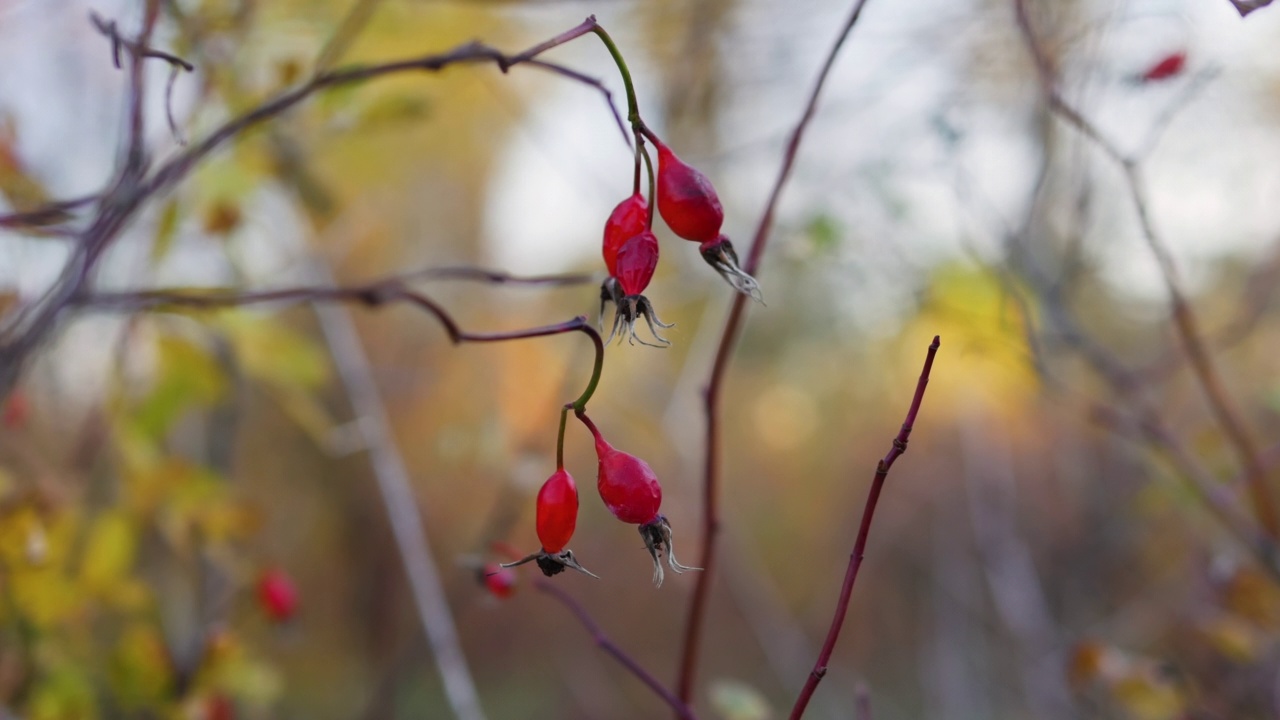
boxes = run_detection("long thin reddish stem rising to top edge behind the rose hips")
[677,0,867,703]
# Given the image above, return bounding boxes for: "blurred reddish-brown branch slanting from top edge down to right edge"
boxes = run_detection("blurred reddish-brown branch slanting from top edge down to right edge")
[1014,0,1280,541]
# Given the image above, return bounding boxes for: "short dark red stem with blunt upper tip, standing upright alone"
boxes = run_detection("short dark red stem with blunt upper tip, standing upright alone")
[791,336,941,720]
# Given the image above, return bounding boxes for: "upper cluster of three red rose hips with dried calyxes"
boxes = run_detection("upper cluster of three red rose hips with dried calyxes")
[600,130,760,345]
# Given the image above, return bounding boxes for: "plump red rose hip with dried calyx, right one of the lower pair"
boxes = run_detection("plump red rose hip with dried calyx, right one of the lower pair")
[579,413,699,587]
